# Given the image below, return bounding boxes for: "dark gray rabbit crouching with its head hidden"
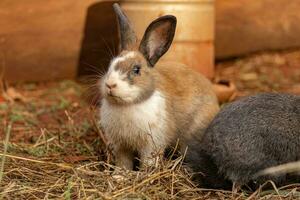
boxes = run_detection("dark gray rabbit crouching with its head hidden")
[186,93,300,189]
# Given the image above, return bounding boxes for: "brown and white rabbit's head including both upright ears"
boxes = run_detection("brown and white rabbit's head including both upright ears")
[101,4,176,104]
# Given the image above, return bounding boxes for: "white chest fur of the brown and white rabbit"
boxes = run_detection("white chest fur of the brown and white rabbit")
[100,91,168,149]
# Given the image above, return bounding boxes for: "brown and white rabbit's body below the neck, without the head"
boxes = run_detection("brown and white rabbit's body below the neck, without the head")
[101,60,219,168]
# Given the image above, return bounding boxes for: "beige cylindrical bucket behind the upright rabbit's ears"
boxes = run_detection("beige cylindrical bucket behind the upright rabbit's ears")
[120,0,214,78]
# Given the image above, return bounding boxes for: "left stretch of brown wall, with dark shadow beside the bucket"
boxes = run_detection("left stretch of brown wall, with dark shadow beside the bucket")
[0,0,116,82]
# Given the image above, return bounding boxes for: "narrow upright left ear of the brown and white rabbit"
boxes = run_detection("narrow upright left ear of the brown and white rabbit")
[113,3,137,50]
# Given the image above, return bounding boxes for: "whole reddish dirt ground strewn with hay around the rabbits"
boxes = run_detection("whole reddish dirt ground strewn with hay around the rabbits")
[0,51,300,199]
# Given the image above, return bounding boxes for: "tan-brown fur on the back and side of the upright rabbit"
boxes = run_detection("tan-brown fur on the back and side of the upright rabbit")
[154,63,219,151]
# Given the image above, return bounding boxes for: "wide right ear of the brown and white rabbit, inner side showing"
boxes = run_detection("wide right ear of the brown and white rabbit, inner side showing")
[139,15,177,67]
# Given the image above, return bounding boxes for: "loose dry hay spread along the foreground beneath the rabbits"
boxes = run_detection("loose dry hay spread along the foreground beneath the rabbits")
[0,139,300,199]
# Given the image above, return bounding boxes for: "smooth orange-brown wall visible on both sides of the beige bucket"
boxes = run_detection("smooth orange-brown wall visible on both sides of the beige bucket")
[0,0,300,82]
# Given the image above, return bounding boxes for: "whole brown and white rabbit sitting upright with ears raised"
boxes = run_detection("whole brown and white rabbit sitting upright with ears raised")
[100,4,219,169]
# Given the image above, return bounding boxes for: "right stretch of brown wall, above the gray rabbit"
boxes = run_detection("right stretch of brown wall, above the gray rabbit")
[215,0,300,58]
